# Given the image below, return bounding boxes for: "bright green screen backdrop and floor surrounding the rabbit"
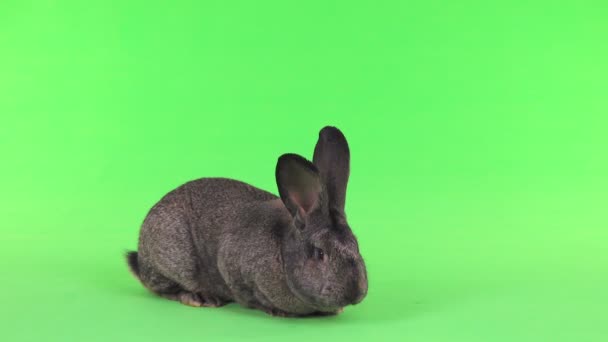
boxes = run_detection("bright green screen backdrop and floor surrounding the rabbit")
[0,0,608,341]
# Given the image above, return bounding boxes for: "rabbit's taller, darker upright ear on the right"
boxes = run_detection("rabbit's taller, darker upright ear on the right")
[312,126,350,212]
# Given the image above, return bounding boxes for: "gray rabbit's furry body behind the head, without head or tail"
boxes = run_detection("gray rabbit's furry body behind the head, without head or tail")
[132,178,315,315]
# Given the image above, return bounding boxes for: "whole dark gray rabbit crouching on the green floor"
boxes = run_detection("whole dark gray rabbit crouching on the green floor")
[127,127,367,317]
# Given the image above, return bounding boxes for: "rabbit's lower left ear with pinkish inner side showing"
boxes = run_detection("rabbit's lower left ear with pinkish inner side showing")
[276,154,322,217]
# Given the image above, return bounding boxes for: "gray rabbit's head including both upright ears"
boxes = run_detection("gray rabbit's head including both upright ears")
[276,127,367,312]
